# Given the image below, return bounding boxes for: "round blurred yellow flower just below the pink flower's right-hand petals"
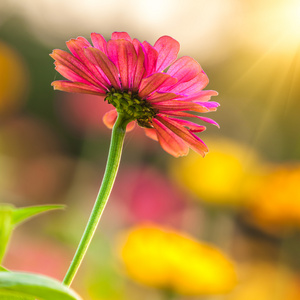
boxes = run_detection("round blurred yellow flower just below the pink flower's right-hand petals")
[170,138,259,205]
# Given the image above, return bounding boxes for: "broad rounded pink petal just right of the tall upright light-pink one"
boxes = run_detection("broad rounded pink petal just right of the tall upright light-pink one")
[167,56,202,84]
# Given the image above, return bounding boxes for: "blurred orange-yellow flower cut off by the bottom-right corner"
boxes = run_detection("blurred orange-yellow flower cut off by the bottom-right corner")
[225,262,300,300]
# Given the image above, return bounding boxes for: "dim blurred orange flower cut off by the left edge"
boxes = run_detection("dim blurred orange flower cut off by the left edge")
[0,41,28,115]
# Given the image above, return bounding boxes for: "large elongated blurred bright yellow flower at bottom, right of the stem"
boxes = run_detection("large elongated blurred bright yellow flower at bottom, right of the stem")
[121,225,237,295]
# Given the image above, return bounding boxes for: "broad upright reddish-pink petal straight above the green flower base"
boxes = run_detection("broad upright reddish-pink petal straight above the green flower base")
[107,40,137,90]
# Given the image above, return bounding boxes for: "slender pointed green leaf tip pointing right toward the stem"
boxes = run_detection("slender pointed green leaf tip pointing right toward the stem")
[12,205,65,226]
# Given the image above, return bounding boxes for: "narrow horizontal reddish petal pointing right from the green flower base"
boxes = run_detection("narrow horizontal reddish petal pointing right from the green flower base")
[153,100,210,113]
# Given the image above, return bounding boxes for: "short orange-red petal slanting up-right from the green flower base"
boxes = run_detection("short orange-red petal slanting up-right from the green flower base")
[139,73,177,98]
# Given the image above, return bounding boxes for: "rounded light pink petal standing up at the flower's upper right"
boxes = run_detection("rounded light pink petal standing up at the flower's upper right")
[154,36,180,72]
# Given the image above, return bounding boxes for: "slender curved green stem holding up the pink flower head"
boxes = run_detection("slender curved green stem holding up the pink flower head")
[63,114,128,286]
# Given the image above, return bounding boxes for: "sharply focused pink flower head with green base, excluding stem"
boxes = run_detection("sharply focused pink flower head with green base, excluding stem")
[51,32,219,157]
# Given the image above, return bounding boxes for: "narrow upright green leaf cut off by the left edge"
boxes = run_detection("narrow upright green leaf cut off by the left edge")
[0,204,14,263]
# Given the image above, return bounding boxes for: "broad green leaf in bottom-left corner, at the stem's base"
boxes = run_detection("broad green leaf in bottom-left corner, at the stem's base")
[0,272,81,300]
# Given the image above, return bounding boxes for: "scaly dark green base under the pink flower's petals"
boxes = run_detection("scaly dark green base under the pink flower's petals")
[104,89,158,128]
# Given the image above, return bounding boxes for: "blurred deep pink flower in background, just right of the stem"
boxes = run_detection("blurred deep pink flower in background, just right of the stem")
[113,168,188,227]
